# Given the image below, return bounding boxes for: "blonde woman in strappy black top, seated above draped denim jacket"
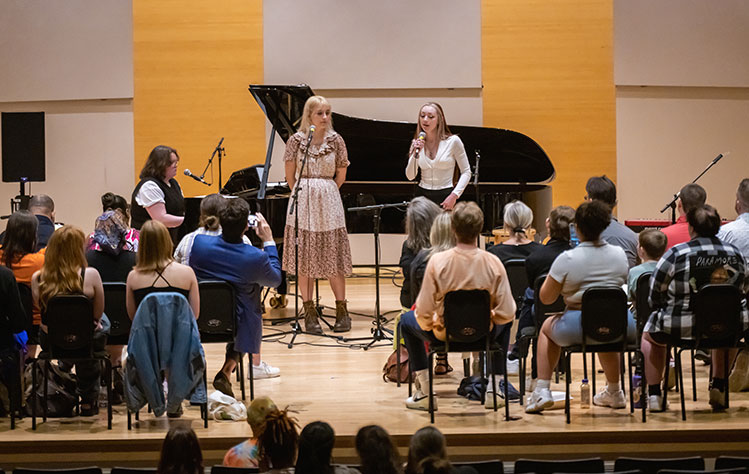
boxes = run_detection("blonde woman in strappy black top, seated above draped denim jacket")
[126,220,200,319]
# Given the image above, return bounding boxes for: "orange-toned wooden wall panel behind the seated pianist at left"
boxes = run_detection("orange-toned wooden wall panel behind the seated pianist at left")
[133,0,265,196]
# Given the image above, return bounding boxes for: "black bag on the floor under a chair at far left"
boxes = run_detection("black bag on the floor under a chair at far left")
[24,362,78,418]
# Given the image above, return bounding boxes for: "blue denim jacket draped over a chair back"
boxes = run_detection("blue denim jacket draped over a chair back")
[125,293,206,416]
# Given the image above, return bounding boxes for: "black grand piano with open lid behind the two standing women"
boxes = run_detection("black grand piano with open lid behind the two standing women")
[187,85,555,236]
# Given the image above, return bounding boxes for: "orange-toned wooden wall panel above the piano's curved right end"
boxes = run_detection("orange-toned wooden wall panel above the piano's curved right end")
[481,0,616,211]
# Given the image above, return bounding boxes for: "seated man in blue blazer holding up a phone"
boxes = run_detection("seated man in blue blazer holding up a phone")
[190,199,281,397]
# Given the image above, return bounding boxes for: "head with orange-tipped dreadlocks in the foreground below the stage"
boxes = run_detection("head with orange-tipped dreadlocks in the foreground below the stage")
[257,408,299,474]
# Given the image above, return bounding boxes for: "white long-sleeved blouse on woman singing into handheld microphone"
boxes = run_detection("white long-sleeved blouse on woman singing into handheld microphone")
[406,135,471,197]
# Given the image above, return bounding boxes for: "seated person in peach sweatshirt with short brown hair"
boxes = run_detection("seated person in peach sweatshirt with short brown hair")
[400,202,515,410]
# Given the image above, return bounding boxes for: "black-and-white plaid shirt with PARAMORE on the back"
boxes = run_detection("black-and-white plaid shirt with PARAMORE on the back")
[644,237,749,339]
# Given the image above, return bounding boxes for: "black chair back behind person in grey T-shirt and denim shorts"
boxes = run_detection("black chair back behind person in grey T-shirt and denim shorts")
[580,287,627,346]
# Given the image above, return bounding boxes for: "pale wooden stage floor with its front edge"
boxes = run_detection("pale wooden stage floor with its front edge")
[0,269,749,470]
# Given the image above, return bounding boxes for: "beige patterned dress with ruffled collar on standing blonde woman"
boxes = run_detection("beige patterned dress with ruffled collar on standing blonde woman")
[283,131,351,278]
